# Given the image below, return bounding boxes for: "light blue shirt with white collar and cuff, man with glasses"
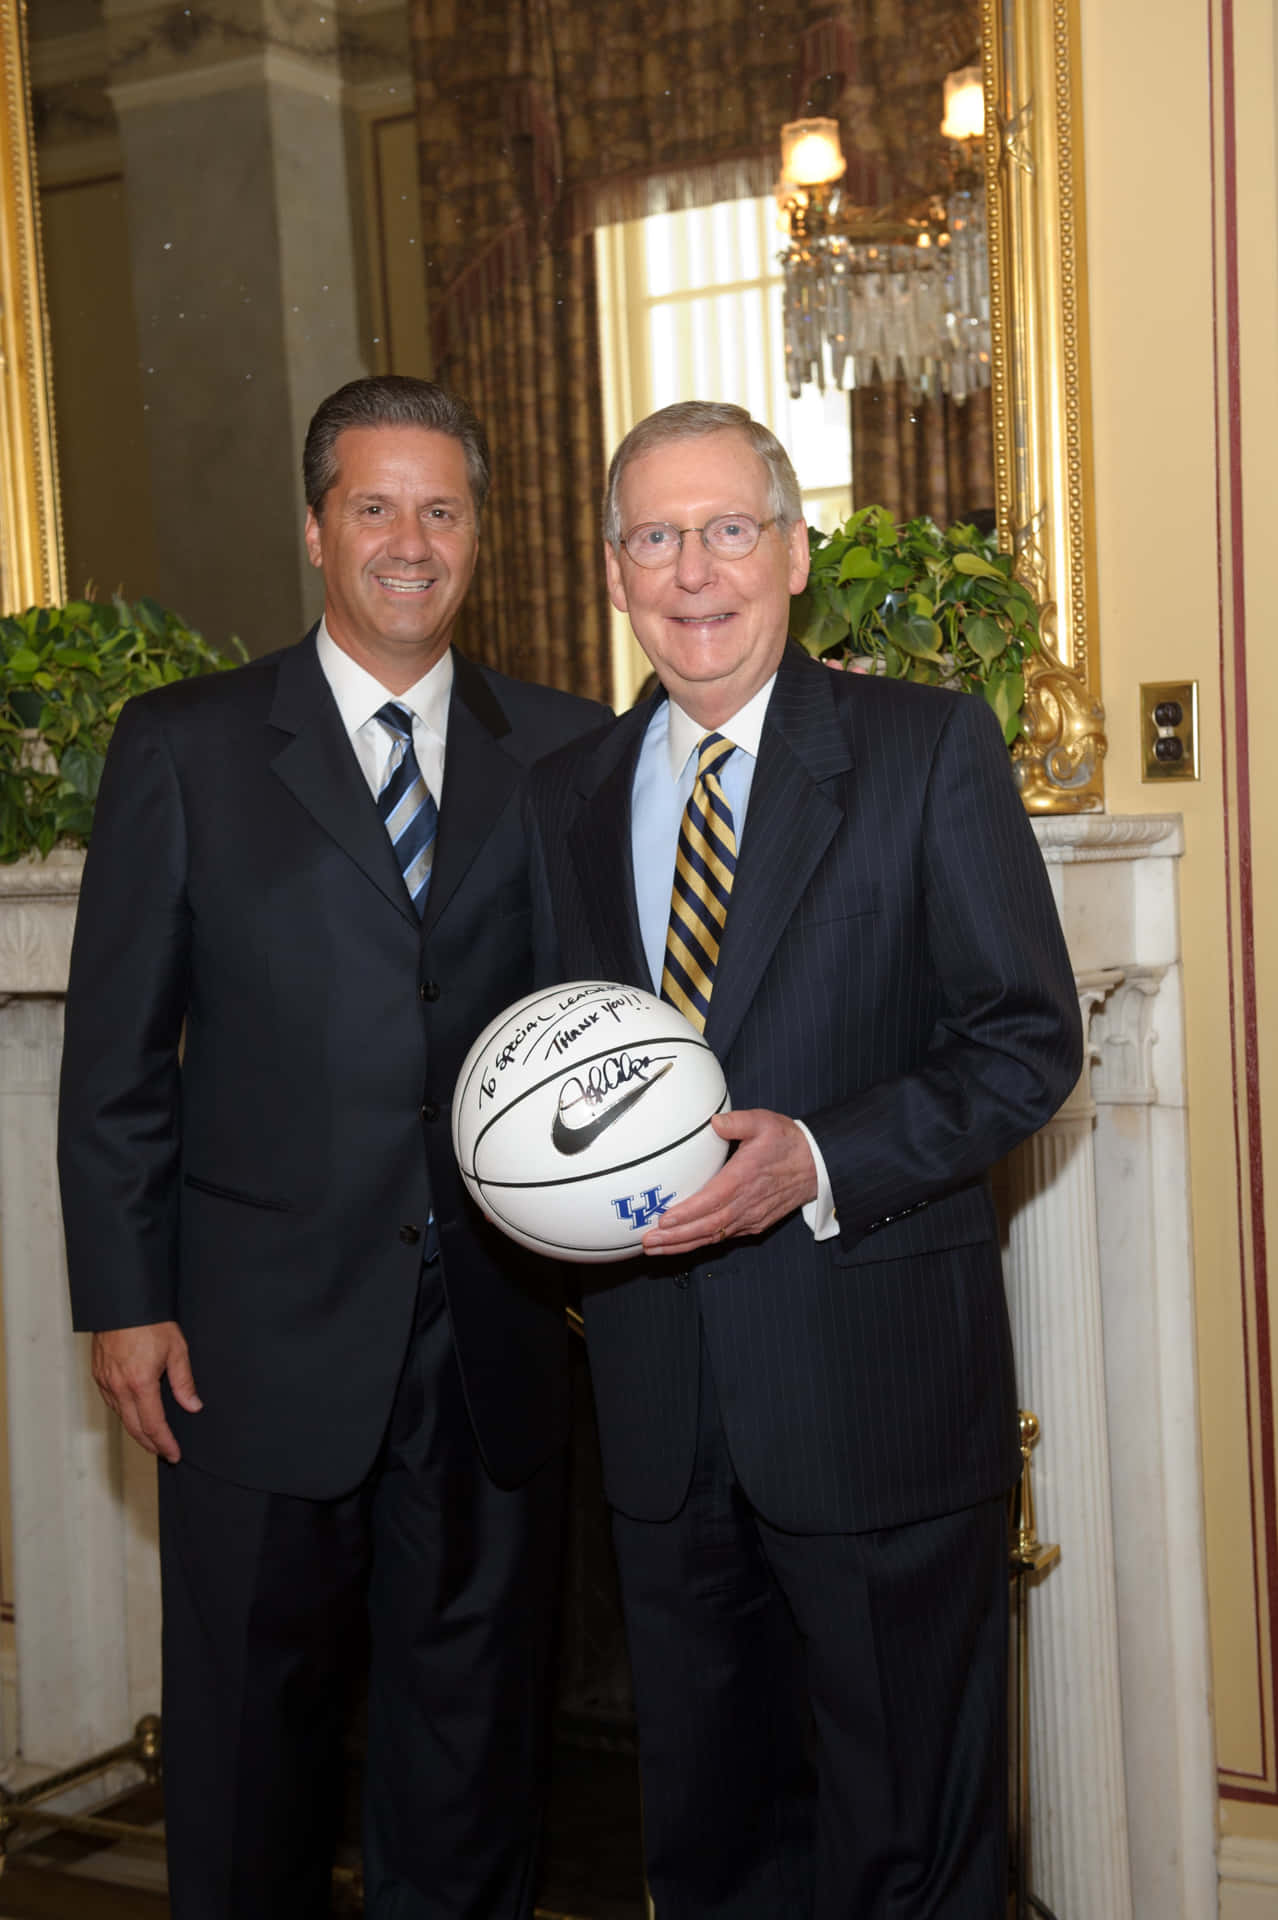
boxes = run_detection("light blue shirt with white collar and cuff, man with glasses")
[629,674,839,1240]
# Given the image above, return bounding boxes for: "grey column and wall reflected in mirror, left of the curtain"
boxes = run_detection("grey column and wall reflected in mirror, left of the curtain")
[29,0,428,653]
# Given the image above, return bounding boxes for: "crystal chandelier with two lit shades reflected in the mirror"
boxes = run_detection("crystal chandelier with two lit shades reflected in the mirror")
[777,67,990,401]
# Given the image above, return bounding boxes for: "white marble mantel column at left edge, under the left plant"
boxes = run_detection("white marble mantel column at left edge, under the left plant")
[0,852,159,1772]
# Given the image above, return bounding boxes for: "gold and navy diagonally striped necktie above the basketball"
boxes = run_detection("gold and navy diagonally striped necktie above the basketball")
[662,733,737,1033]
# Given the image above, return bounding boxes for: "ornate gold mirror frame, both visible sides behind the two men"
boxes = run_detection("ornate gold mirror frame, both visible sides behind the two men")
[0,0,1105,812]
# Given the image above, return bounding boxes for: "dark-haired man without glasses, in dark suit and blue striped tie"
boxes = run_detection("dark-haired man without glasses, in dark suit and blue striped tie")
[59,376,603,1920]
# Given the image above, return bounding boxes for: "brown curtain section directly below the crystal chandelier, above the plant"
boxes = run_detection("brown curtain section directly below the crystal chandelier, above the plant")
[850,380,994,526]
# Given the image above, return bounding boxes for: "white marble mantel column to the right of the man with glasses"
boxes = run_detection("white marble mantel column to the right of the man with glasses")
[1007,814,1217,1920]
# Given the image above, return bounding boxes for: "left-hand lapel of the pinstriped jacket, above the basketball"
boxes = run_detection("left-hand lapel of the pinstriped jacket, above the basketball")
[568,701,660,993]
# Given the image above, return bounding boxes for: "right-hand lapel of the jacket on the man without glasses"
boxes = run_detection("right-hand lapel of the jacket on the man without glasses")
[426,651,524,933]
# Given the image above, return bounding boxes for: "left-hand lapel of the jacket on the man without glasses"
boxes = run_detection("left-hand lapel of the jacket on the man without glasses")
[271,632,416,925]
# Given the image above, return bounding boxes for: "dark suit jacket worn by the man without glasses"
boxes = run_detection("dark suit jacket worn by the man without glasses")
[59,636,601,1498]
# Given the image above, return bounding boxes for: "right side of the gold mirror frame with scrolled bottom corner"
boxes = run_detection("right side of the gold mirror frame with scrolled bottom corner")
[981,0,1105,814]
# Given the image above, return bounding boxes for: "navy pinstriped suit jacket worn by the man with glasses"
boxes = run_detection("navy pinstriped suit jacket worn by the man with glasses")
[530,649,1082,1532]
